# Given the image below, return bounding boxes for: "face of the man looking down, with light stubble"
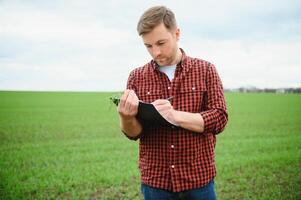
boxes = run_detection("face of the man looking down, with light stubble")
[142,23,180,66]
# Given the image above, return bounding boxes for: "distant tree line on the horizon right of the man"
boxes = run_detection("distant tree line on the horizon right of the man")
[224,87,301,94]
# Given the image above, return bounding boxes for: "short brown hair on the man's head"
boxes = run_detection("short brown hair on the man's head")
[137,6,177,35]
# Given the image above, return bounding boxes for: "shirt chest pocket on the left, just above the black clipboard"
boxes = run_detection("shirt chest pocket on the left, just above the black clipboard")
[138,88,163,103]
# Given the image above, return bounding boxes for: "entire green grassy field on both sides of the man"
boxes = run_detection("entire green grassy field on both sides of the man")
[0,91,301,200]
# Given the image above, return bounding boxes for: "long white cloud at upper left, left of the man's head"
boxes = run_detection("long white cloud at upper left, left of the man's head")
[0,6,130,48]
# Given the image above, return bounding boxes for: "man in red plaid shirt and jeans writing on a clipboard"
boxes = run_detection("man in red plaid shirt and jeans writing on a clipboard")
[118,6,228,200]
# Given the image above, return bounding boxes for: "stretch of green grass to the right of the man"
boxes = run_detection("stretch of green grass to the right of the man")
[216,94,301,199]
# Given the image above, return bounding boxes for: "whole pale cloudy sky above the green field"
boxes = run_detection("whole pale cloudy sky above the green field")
[0,0,301,91]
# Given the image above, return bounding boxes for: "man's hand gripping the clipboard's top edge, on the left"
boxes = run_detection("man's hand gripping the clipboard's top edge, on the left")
[117,89,139,119]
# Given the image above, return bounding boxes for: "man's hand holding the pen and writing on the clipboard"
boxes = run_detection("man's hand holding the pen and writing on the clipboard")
[152,99,178,126]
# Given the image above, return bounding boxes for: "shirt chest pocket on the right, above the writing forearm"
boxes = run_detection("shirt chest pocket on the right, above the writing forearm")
[177,84,207,113]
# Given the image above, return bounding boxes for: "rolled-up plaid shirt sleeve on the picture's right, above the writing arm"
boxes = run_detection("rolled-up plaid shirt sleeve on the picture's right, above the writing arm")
[201,64,228,134]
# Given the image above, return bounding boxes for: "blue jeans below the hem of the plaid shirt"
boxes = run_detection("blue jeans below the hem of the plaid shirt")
[141,180,216,200]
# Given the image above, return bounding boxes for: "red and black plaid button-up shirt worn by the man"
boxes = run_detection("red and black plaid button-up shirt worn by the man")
[127,50,228,192]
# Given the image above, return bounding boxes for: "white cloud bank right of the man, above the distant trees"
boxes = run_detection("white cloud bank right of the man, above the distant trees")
[185,40,301,88]
